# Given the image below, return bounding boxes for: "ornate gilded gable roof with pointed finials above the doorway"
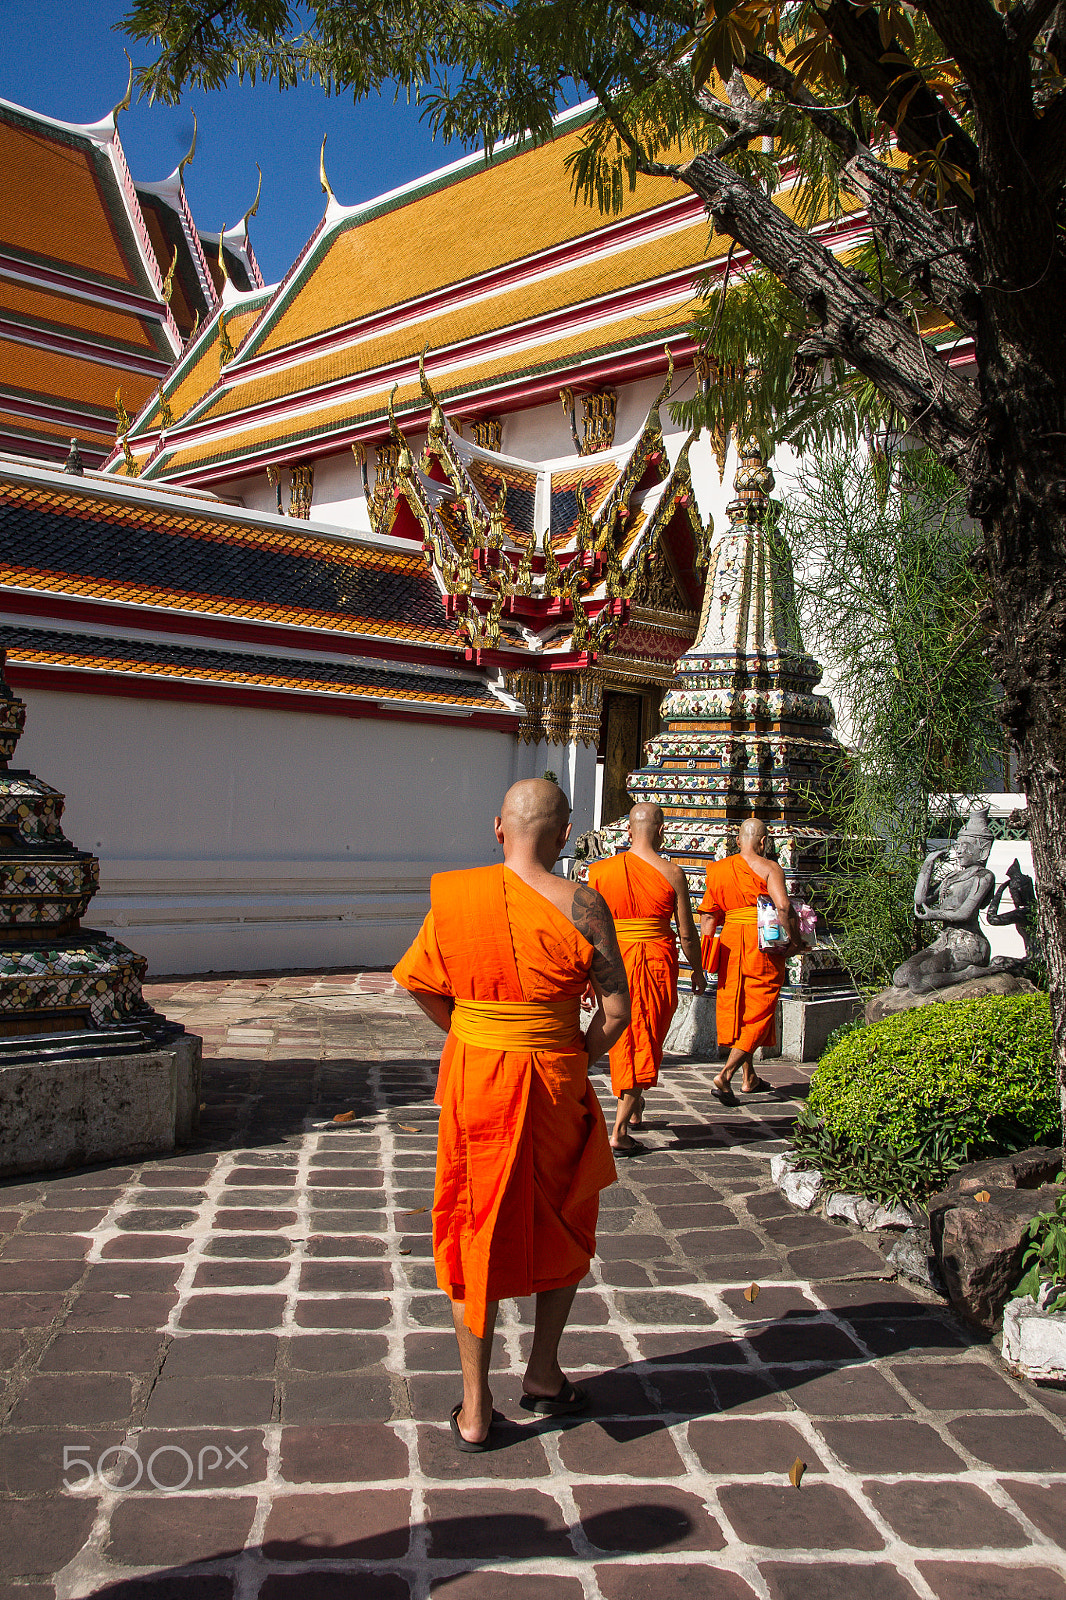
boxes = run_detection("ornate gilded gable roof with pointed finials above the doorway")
[377,352,711,684]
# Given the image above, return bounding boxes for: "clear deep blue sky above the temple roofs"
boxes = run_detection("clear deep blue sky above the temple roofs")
[0,0,463,283]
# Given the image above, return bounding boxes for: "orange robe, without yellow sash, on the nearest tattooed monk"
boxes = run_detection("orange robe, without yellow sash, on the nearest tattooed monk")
[392,866,616,1338]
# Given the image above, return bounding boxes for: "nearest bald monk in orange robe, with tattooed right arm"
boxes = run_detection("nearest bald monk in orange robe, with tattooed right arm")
[392,778,629,1451]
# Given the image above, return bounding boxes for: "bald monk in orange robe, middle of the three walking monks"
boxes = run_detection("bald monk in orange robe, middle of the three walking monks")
[589,803,707,1155]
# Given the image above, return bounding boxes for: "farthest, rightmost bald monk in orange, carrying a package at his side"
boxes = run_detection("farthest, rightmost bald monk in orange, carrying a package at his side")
[699,818,800,1106]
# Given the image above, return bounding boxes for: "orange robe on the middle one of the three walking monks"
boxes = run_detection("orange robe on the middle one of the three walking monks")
[589,850,677,1096]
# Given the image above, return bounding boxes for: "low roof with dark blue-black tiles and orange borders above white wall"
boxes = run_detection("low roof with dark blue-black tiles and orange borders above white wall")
[0,461,514,726]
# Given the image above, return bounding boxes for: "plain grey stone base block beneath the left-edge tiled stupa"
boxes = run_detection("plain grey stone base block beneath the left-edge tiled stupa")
[0,1034,200,1178]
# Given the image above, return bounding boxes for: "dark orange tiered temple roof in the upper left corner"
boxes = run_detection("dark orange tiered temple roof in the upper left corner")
[0,101,261,464]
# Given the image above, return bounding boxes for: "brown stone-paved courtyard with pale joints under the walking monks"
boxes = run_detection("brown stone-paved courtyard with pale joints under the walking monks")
[0,973,1066,1600]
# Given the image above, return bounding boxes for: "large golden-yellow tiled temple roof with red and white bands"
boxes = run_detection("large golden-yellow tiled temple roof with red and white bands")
[109,107,848,483]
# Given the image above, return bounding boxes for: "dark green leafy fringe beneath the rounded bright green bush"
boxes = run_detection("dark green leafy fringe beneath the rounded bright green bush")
[791,1106,970,1205]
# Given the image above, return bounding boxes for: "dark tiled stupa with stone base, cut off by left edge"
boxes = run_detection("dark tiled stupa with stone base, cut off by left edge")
[0,650,200,1174]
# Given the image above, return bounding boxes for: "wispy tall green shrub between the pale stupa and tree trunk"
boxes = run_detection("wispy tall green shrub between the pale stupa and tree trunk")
[779,446,1004,990]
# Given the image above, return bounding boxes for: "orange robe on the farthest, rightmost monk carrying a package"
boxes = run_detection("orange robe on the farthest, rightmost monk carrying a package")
[699,856,784,1050]
